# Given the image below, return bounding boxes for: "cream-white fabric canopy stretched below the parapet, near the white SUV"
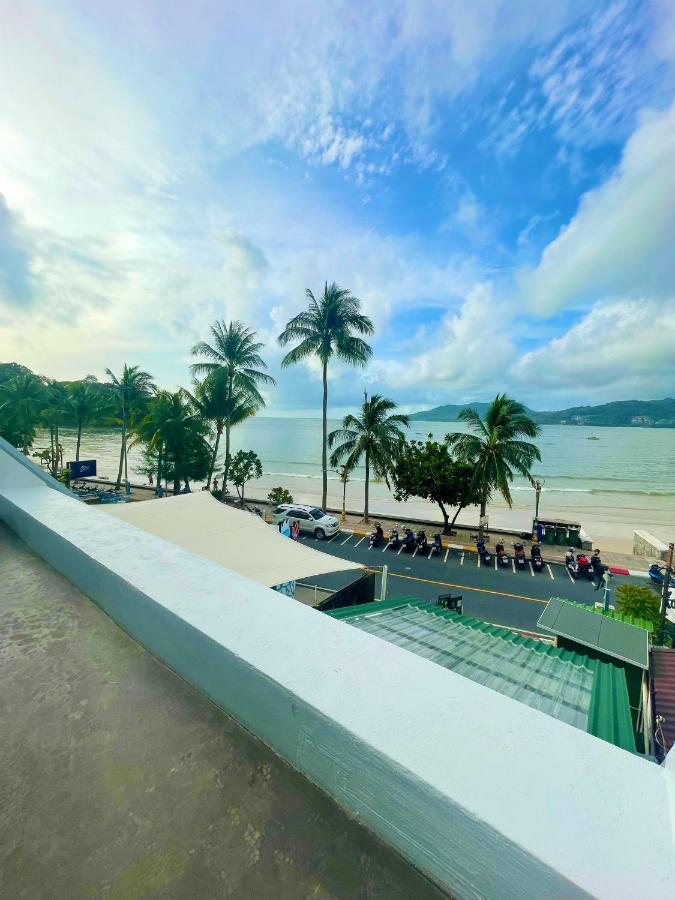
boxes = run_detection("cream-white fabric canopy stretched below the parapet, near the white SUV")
[100,491,363,587]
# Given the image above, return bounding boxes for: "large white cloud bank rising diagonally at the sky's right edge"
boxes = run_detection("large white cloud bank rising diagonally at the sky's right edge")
[519,103,675,314]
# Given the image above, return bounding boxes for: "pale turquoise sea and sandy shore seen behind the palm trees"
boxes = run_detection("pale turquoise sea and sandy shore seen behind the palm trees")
[36,416,675,552]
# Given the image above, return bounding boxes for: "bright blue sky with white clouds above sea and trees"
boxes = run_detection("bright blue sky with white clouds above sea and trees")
[0,0,675,414]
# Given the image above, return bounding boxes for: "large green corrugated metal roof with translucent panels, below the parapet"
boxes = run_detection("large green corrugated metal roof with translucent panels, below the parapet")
[329,599,635,752]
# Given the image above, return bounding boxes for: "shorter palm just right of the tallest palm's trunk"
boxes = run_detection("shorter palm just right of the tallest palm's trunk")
[328,392,409,524]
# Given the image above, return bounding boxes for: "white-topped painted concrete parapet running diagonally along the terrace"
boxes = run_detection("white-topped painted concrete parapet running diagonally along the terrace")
[0,432,675,898]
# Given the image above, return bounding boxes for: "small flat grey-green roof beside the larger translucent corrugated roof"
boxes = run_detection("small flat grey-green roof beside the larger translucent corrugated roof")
[537,597,649,669]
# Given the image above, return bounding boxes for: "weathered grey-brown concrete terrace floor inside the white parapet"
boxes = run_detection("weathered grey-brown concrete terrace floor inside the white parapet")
[0,525,444,900]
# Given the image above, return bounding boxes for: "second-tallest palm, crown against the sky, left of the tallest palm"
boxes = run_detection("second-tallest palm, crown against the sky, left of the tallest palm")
[190,320,276,491]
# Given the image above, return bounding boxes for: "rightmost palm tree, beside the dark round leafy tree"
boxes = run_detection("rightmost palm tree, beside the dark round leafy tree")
[446,394,541,537]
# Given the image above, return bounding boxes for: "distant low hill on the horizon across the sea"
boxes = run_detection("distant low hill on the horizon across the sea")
[410,398,675,428]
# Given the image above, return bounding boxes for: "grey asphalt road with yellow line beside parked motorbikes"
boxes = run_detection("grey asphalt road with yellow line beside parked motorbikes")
[301,533,645,633]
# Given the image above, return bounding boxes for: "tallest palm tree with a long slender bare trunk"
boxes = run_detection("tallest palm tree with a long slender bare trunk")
[278,282,374,509]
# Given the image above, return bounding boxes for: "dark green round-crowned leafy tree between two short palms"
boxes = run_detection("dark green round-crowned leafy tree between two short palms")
[391,435,480,534]
